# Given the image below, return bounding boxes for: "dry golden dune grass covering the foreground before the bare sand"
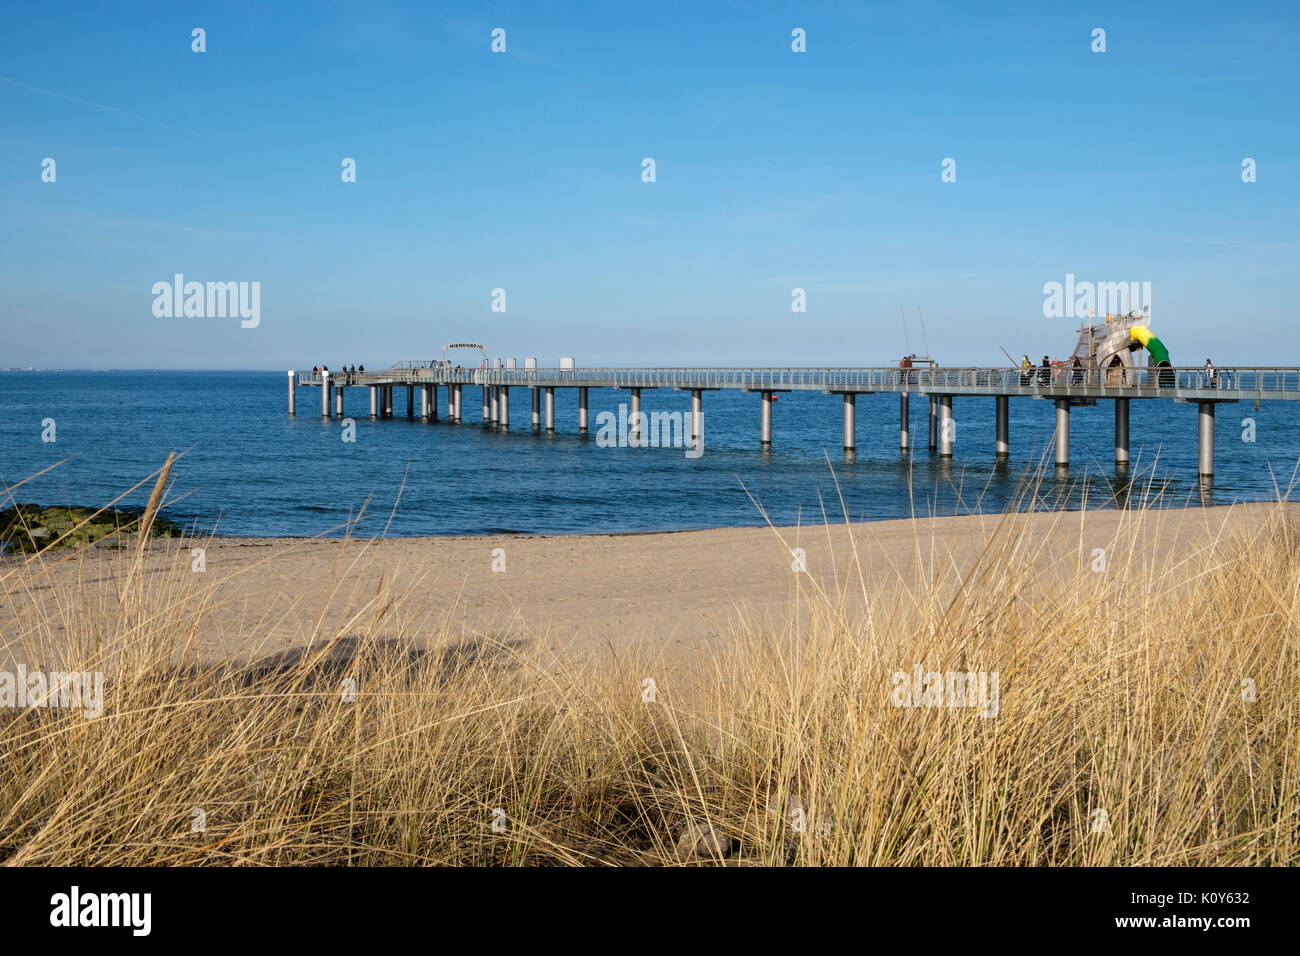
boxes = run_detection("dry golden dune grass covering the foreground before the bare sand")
[0,460,1300,865]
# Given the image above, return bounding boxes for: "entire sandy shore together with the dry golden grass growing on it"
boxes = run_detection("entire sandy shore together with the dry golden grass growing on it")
[0,505,1300,866]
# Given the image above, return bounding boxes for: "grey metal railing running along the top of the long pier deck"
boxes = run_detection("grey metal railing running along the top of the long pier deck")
[296,363,1300,401]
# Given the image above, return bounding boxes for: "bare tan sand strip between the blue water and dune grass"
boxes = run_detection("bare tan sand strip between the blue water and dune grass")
[0,505,1274,661]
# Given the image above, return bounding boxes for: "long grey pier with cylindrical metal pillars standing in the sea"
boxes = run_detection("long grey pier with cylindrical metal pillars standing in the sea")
[289,359,1300,480]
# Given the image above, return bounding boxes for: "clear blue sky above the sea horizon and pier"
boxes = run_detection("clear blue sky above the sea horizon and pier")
[0,1,1300,368]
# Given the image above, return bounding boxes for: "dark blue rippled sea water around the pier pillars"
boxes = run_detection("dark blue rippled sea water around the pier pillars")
[0,372,1300,536]
